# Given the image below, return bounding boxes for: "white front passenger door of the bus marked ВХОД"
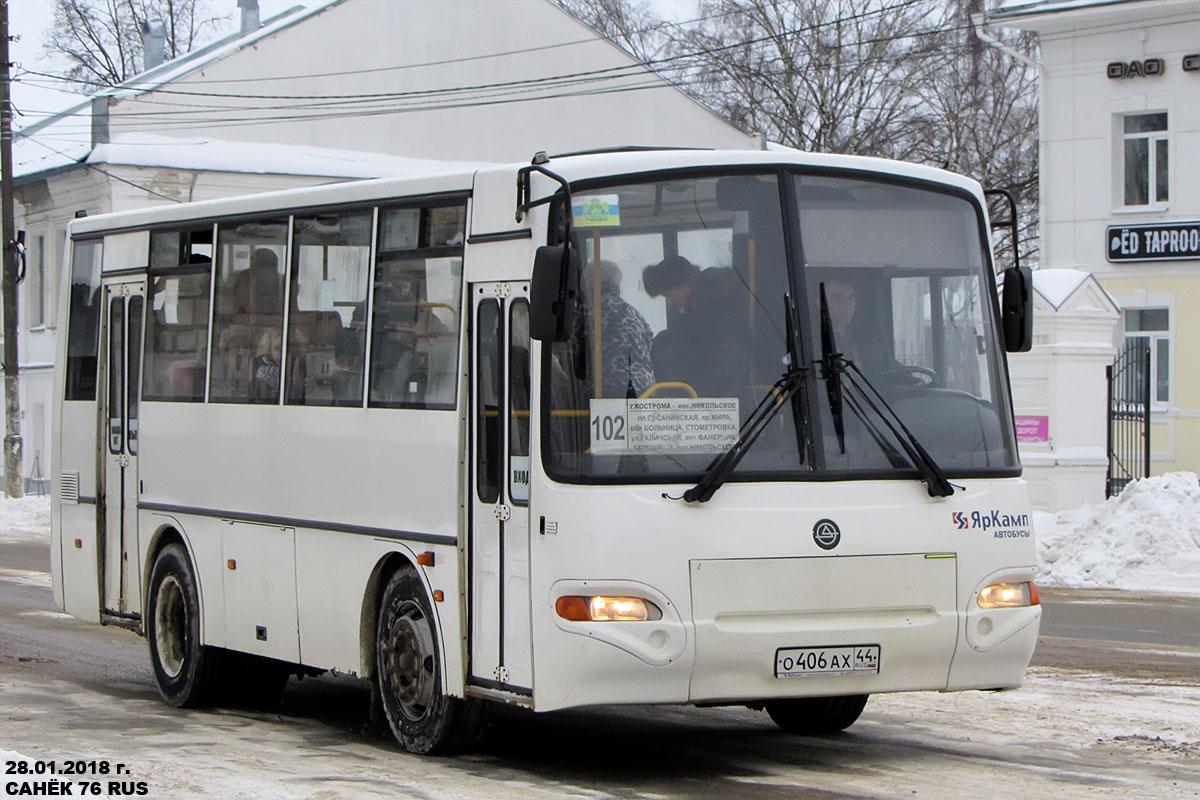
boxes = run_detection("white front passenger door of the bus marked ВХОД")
[468,282,533,694]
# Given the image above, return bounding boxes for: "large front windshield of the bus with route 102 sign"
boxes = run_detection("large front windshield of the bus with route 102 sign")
[542,172,1018,482]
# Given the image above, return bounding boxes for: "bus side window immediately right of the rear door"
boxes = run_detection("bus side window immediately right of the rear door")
[142,225,212,403]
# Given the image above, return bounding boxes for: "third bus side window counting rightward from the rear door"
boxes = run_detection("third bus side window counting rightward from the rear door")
[286,211,372,405]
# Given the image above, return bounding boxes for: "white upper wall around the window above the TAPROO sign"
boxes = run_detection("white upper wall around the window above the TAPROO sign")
[1040,2,1200,278]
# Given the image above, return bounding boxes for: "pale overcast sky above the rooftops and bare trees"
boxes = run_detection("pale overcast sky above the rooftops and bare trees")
[8,0,697,128]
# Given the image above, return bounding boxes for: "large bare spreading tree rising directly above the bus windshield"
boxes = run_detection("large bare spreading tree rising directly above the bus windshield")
[683,0,934,158]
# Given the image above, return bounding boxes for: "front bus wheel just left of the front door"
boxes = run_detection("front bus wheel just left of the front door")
[376,566,488,756]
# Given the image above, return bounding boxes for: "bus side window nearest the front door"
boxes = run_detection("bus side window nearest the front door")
[368,205,466,409]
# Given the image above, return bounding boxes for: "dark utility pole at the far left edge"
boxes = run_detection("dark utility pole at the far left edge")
[0,0,25,498]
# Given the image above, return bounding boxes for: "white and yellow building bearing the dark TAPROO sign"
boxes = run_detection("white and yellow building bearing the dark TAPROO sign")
[988,0,1200,482]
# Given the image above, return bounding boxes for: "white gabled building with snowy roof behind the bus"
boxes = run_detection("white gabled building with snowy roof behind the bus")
[13,0,760,489]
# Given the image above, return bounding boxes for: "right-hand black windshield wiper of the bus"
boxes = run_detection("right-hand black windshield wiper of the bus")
[820,283,954,498]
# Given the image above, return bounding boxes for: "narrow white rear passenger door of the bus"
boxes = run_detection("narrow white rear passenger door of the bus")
[97,278,145,620]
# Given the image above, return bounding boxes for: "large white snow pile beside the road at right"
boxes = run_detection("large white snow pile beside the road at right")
[1034,473,1200,594]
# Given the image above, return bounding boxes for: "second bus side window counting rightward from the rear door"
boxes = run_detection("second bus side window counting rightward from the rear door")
[209,219,288,403]
